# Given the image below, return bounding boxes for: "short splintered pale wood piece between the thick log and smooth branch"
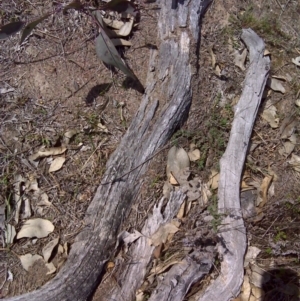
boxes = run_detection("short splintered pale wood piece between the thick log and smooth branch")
[93,191,186,301]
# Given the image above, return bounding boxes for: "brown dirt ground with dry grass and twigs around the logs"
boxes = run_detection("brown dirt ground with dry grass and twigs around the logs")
[0,0,300,300]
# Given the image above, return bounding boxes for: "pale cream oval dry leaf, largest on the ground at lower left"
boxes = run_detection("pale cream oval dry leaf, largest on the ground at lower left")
[17,218,54,239]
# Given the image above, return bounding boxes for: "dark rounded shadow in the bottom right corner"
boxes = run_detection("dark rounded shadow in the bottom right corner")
[260,268,300,301]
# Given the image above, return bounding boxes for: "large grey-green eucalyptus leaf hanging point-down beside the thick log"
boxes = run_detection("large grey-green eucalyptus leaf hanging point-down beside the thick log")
[96,28,137,80]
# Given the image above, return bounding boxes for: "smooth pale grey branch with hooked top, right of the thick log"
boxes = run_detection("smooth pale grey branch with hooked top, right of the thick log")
[198,29,270,301]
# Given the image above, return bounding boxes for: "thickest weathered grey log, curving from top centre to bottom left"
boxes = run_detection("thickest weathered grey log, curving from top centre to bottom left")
[4,0,211,301]
